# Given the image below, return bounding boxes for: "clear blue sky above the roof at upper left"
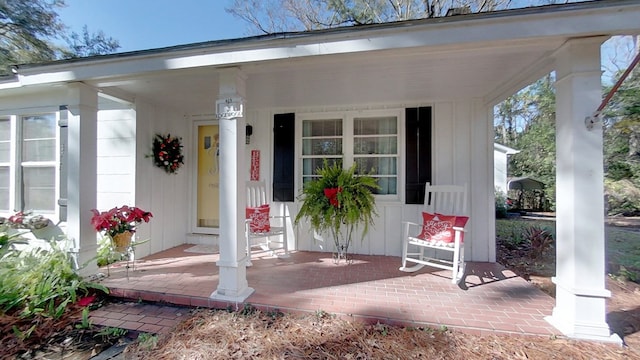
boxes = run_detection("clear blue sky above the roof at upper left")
[58,0,249,52]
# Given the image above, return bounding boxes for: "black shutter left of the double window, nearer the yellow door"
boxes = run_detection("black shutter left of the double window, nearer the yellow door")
[273,113,296,201]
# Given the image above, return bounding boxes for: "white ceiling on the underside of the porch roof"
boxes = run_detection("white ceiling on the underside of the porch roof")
[88,39,564,115]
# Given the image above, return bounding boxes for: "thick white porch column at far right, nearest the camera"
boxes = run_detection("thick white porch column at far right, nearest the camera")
[547,38,621,343]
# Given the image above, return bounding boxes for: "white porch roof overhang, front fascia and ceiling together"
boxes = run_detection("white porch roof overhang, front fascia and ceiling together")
[0,0,640,113]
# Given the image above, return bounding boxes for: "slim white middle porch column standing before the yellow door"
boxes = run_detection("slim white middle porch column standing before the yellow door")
[211,69,254,302]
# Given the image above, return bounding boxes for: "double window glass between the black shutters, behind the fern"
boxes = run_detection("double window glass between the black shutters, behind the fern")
[301,112,400,199]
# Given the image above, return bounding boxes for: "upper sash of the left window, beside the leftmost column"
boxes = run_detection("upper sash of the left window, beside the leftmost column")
[22,114,56,161]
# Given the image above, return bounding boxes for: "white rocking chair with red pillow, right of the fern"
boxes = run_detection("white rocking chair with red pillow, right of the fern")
[400,183,469,284]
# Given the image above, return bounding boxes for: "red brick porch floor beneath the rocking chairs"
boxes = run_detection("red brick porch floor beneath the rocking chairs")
[91,245,560,335]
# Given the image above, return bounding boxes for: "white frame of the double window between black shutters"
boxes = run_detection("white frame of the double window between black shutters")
[295,108,405,202]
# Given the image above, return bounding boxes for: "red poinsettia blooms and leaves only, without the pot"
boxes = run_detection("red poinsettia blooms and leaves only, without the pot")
[91,205,153,238]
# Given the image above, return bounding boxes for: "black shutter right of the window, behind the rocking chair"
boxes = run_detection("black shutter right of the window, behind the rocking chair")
[405,106,431,204]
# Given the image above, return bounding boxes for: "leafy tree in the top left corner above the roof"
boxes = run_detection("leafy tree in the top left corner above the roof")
[0,0,120,75]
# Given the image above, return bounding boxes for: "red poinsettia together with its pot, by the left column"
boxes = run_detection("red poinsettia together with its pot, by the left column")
[91,205,153,253]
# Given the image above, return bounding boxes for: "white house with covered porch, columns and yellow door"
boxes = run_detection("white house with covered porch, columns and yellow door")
[0,0,640,340]
